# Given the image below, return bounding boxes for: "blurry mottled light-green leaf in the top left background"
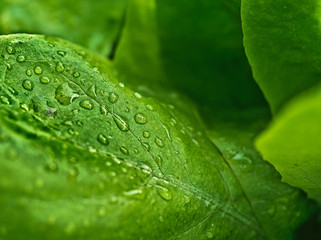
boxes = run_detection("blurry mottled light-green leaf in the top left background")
[0,0,127,56]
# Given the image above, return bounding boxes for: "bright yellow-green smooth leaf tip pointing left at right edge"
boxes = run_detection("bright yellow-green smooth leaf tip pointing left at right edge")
[256,86,321,203]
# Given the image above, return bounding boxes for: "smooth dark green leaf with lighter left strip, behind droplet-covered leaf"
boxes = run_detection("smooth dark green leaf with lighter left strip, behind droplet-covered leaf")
[115,0,265,110]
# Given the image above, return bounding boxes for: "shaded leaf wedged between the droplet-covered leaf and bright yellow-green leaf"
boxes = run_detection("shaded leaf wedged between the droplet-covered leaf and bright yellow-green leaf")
[209,111,313,239]
